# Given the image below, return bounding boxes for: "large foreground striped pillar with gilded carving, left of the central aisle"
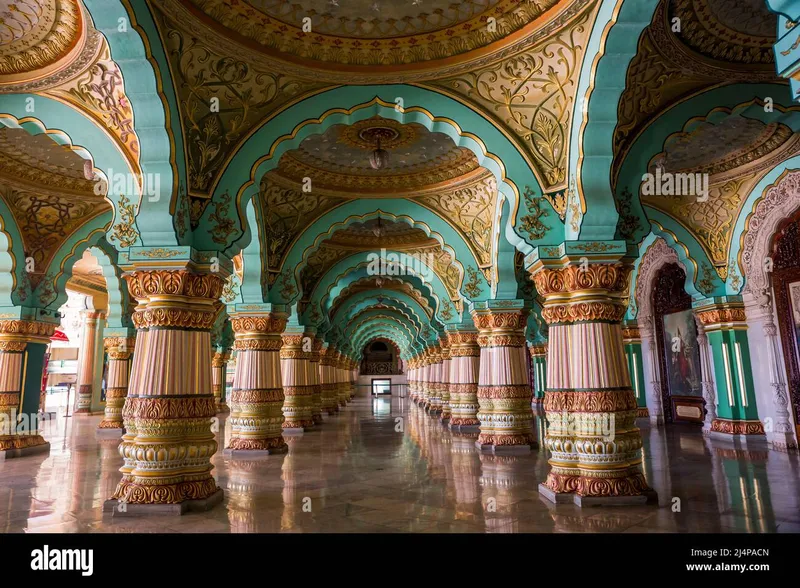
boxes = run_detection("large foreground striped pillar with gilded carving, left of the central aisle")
[104,269,224,514]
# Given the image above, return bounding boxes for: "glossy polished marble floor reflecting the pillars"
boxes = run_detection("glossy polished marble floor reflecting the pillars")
[0,397,800,533]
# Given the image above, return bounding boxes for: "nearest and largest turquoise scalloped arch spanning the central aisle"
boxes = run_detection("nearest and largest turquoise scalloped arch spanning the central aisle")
[209,84,552,255]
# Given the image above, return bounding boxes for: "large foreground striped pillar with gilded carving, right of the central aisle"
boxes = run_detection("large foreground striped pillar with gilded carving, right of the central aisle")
[531,260,654,506]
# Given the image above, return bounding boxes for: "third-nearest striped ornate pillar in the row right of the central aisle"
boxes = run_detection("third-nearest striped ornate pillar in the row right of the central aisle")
[448,329,481,433]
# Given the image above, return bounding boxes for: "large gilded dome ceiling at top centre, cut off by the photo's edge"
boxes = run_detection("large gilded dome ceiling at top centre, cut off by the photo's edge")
[181,0,571,69]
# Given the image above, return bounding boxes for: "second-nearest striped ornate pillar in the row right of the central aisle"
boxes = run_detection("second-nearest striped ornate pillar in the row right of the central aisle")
[472,300,536,453]
